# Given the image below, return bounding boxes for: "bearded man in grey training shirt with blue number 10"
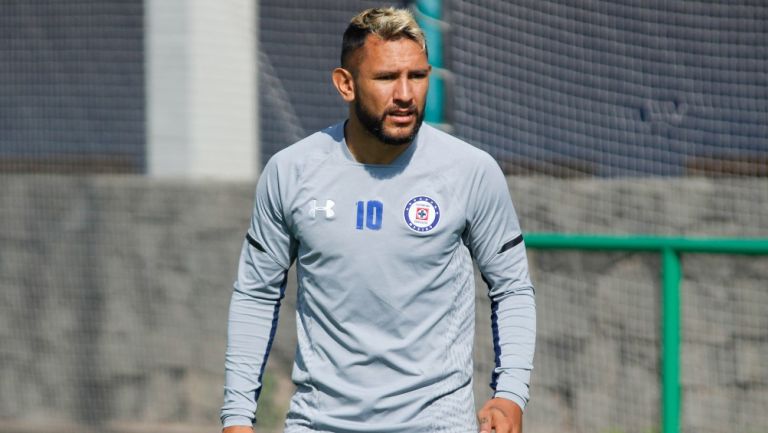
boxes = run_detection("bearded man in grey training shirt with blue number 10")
[221,8,535,433]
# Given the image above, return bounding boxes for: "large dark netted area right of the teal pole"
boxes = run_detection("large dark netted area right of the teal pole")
[448,0,768,176]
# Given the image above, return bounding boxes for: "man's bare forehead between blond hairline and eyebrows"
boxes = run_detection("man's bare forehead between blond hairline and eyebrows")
[358,35,429,71]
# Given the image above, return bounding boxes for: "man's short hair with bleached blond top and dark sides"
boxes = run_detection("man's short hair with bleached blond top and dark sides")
[341,7,427,69]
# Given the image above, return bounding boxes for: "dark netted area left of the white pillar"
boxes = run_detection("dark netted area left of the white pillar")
[0,0,145,173]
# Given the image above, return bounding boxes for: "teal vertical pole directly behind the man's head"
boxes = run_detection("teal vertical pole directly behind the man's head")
[416,0,445,126]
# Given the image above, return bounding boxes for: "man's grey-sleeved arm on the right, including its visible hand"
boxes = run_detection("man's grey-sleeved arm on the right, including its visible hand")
[466,153,536,433]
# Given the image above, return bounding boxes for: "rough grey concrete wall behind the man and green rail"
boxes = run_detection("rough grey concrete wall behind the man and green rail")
[0,176,768,432]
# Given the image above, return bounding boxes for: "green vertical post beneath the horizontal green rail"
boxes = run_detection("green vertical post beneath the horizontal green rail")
[661,247,682,433]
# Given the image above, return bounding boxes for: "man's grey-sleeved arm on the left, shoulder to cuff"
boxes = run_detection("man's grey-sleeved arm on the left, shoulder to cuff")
[221,161,297,433]
